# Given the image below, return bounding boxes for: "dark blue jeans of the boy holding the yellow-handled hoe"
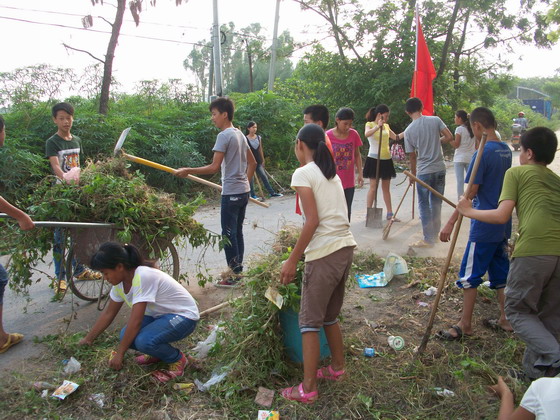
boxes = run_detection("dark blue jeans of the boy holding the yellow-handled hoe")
[221,193,249,274]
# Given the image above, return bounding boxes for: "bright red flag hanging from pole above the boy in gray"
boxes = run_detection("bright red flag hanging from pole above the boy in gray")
[410,11,436,115]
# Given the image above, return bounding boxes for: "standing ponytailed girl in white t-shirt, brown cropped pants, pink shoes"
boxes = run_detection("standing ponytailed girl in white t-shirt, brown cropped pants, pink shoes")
[280,124,356,404]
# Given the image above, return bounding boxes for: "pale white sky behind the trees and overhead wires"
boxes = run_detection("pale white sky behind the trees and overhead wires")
[0,0,560,90]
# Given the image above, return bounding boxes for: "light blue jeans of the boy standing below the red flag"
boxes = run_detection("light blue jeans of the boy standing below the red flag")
[417,171,445,244]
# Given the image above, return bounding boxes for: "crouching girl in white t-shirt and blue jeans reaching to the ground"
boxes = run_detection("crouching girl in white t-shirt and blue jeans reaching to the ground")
[80,242,199,382]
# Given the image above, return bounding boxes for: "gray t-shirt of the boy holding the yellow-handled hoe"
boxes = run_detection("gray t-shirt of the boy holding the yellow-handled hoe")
[212,127,250,195]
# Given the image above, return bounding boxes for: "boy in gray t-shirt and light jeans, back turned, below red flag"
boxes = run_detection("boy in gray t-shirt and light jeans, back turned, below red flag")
[404,98,453,247]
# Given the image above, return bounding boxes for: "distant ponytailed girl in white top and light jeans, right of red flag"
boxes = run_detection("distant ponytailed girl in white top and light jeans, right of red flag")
[449,109,476,198]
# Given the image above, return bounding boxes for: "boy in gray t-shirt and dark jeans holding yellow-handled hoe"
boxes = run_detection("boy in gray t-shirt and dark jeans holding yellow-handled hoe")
[175,97,257,287]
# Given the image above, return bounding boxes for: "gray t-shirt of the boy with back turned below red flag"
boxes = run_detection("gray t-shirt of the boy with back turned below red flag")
[404,115,447,175]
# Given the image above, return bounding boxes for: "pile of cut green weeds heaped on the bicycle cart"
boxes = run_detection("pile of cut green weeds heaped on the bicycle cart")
[2,159,219,292]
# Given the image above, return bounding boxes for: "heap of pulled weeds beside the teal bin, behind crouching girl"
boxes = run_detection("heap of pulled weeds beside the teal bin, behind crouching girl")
[206,227,303,396]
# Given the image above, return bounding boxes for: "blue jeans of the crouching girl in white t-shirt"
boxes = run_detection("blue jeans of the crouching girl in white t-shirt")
[121,314,198,363]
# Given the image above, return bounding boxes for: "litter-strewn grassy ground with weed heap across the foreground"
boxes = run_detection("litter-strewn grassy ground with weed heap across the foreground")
[0,230,527,419]
